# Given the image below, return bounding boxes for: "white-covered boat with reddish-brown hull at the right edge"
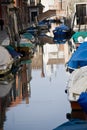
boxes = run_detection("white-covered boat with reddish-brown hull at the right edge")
[67,66,87,112]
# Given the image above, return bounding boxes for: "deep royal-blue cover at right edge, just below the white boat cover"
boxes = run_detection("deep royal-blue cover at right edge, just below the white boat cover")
[77,92,87,113]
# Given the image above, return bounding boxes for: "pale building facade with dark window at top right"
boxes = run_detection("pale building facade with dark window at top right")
[68,0,87,30]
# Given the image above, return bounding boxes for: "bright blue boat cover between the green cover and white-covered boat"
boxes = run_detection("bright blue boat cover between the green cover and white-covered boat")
[67,42,87,69]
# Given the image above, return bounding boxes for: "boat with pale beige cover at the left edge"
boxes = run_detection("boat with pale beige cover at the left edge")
[0,46,14,76]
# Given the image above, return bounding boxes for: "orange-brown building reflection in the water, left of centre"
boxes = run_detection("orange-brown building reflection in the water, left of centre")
[11,61,31,106]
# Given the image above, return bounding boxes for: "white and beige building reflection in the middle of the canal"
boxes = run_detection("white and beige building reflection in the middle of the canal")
[32,23,70,81]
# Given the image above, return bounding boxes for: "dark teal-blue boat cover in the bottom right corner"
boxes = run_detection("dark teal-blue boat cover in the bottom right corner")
[53,119,87,130]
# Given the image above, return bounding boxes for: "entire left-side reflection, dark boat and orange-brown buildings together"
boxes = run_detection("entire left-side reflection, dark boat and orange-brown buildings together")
[0,60,32,130]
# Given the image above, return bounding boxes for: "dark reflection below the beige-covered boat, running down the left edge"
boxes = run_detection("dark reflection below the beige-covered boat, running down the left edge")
[0,73,15,130]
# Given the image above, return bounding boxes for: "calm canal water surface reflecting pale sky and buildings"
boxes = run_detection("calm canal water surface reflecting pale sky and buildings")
[0,23,71,130]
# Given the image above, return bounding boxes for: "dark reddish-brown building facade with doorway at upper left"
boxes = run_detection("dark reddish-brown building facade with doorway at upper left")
[0,0,44,27]
